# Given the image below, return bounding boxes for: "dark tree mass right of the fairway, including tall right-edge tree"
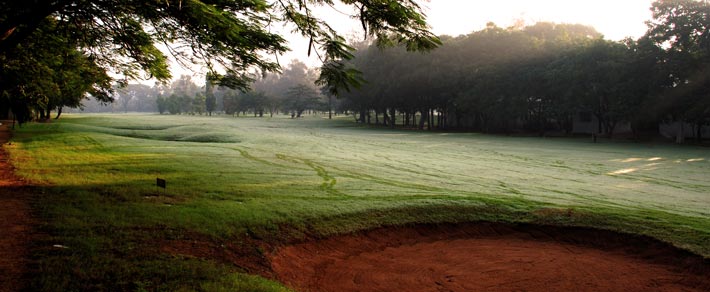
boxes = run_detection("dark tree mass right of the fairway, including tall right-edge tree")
[332,0,710,138]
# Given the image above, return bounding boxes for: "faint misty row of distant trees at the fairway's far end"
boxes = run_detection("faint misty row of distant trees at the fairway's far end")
[76,60,342,118]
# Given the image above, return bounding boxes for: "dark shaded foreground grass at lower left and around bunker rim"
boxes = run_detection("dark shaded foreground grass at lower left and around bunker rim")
[20,176,710,291]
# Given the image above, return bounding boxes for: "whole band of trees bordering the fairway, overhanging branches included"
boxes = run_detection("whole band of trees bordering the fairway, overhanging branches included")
[0,0,710,139]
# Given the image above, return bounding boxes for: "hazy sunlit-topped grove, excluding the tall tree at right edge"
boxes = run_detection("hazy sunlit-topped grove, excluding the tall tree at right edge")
[342,23,613,132]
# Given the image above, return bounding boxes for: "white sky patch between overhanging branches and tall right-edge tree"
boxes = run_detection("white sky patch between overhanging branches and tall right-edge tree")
[425,0,652,40]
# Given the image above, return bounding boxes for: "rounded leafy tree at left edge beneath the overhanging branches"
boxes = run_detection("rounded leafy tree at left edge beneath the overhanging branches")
[0,19,113,123]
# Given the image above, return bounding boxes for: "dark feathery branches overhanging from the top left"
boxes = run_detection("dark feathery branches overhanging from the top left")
[0,0,440,124]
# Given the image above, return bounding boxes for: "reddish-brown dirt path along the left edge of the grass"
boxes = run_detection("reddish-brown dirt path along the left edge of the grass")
[0,121,32,292]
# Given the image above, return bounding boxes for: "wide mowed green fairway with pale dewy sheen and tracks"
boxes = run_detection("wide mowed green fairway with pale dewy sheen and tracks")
[6,115,710,291]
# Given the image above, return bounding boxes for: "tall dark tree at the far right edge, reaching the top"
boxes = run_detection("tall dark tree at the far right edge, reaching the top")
[645,0,710,142]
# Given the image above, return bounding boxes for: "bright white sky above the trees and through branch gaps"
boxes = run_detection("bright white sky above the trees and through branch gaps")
[165,0,652,81]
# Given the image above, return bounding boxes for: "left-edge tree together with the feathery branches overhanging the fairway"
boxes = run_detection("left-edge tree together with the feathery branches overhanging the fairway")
[0,0,440,123]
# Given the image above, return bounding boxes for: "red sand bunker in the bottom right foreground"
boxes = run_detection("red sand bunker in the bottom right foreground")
[271,223,710,292]
